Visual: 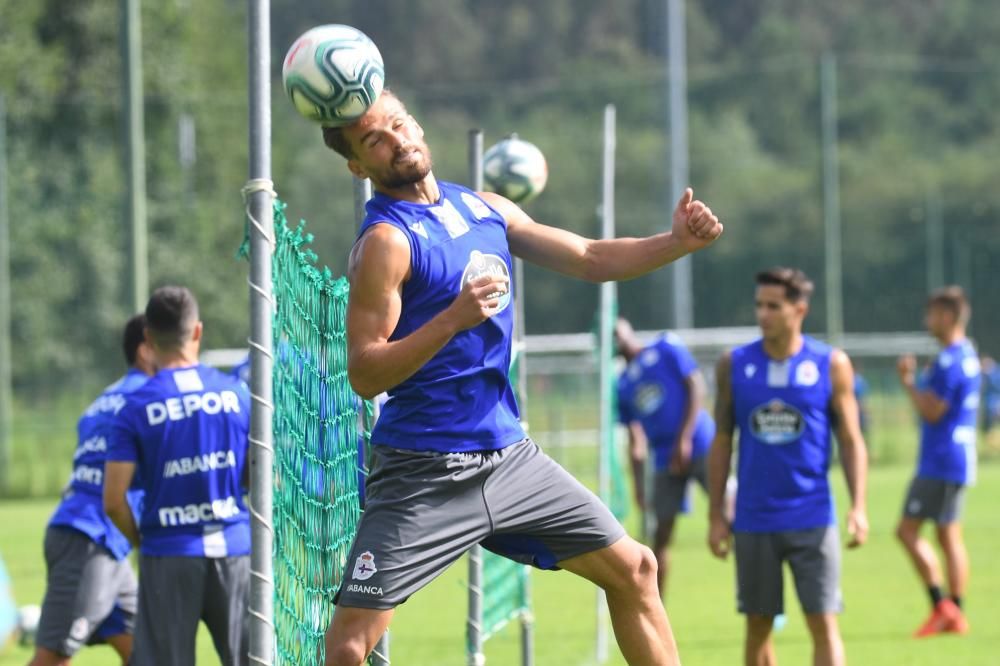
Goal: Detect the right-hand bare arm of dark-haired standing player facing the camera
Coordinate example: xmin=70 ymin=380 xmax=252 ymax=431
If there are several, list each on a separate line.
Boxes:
xmin=830 ymin=349 xmax=868 ymax=548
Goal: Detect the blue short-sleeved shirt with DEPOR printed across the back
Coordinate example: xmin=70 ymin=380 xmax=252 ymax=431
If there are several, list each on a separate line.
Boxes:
xmin=108 ymin=365 xmax=250 ymax=557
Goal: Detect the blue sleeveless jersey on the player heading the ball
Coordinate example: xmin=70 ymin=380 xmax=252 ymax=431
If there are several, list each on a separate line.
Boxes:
xmin=359 ymin=182 xmax=525 ymax=452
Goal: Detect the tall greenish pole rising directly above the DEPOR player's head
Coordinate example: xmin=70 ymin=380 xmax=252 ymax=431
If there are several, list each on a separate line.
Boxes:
xmin=121 ymin=0 xmax=149 ymax=312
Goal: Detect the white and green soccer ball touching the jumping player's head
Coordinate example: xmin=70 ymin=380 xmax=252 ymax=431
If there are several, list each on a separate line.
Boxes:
xmin=281 ymin=24 xmax=385 ymax=127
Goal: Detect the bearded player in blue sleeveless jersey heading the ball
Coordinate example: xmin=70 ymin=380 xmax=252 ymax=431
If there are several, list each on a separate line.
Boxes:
xmin=323 ymin=92 xmax=722 ymax=666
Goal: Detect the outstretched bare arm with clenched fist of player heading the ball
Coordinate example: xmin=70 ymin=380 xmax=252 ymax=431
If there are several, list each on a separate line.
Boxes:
xmin=479 ymin=188 xmax=723 ymax=282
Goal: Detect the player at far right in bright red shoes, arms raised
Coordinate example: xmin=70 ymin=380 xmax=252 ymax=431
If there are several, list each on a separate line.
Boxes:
xmin=896 ymin=287 xmax=980 ymax=637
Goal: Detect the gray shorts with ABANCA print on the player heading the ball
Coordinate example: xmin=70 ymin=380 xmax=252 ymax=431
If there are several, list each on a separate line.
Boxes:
xmin=336 ymin=440 xmax=625 ymax=609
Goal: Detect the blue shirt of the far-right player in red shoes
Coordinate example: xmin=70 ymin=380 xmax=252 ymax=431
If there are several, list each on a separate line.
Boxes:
xmin=917 ymin=340 xmax=980 ymax=485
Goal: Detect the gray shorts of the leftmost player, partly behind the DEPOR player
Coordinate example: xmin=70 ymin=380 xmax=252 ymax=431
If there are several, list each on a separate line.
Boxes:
xmin=35 ymin=526 xmax=137 ymax=657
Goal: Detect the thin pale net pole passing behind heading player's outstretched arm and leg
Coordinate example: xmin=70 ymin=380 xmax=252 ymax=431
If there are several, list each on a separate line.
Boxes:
xmin=596 ymin=104 xmax=617 ymax=664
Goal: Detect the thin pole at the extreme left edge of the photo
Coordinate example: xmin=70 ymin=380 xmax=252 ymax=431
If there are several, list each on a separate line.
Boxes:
xmin=0 ymin=95 xmax=14 ymax=497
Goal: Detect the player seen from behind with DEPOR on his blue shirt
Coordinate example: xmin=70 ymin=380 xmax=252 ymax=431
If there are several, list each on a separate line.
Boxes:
xmin=104 ymin=287 xmax=250 ymax=666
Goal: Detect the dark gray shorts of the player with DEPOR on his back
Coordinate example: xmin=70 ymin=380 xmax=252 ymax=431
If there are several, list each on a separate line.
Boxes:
xmin=129 ymin=555 xmax=250 ymax=666
